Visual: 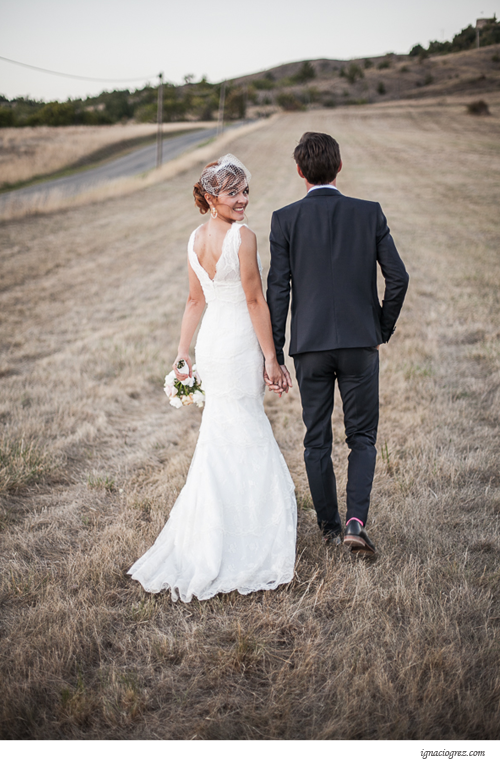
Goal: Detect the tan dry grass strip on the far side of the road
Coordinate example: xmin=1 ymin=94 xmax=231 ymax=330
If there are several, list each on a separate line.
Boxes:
xmin=0 ymin=122 xmax=213 ymax=187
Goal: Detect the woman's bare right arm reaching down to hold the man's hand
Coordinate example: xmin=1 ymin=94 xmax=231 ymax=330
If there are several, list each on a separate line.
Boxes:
xmin=238 ymin=227 xmax=284 ymax=388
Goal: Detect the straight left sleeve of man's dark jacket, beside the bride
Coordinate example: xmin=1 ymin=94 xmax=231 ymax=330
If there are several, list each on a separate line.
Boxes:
xmin=267 ymin=211 xmax=291 ymax=366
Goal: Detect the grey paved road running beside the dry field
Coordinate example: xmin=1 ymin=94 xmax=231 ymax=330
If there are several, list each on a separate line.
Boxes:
xmin=0 ymin=127 xmax=221 ymax=211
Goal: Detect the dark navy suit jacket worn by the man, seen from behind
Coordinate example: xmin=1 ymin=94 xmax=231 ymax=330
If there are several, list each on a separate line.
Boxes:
xmin=267 ymin=187 xmax=409 ymax=364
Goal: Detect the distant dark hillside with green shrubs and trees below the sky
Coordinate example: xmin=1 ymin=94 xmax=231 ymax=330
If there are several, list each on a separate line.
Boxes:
xmin=0 ymin=18 xmax=500 ymax=127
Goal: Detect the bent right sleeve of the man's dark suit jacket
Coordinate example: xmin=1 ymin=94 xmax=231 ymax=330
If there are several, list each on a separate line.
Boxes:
xmin=377 ymin=206 xmax=409 ymax=342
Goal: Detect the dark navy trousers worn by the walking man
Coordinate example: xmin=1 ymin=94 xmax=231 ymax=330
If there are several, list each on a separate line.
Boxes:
xmin=294 ymin=347 xmax=379 ymax=532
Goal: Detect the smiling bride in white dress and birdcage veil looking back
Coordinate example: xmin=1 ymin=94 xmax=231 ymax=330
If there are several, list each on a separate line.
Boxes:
xmin=128 ymin=155 xmax=297 ymax=602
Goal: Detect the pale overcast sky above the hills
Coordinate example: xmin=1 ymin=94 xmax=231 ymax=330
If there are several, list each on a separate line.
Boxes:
xmin=0 ymin=0 xmax=500 ymax=100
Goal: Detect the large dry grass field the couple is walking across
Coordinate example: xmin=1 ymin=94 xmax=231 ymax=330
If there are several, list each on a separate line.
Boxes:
xmin=0 ymin=95 xmax=500 ymax=740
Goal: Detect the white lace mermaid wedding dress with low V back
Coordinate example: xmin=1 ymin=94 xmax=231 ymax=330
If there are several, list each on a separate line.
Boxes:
xmin=128 ymin=223 xmax=297 ymax=602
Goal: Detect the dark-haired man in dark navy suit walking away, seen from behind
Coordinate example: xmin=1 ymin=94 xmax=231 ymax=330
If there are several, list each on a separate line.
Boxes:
xmin=267 ymin=133 xmax=408 ymax=555
